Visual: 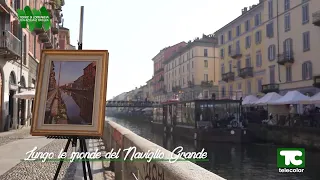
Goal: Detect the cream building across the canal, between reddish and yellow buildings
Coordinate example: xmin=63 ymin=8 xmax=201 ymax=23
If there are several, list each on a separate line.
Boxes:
xmin=164 ymin=35 xmax=219 ymax=99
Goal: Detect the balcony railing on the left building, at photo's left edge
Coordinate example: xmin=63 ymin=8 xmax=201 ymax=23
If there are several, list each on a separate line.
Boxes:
xmin=0 ymin=30 xmax=21 ymax=56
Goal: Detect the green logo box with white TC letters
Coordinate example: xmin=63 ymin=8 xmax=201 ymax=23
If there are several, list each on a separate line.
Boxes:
xmin=277 ymin=148 xmax=306 ymax=168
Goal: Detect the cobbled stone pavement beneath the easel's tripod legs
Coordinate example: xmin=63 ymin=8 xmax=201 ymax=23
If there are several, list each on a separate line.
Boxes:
xmin=0 ymin=128 xmax=114 ymax=180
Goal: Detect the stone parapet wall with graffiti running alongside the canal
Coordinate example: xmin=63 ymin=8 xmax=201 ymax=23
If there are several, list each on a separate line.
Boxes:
xmin=103 ymin=121 xmax=224 ymax=180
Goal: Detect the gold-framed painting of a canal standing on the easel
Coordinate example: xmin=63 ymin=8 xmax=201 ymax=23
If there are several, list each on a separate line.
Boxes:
xmin=30 ymin=50 xmax=109 ymax=137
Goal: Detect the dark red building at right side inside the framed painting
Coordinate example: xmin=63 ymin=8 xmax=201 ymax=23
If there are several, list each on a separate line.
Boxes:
xmin=83 ymin=62 xmax=96 ymax=91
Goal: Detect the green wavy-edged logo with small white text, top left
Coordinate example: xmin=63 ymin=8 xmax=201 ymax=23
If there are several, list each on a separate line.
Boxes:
xmin=17 ymin=6 xmax=51 ymax=31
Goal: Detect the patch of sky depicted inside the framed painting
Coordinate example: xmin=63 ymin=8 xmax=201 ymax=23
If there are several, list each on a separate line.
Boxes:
xmin=53 ymin=61 xmax=92 ymax=86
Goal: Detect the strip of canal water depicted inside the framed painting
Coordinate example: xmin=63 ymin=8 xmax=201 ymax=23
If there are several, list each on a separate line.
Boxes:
xmin=61 ymin=91 xmax=84 ymax=124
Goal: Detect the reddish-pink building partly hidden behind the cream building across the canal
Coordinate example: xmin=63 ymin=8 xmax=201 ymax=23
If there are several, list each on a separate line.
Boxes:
xmin=152 ymin=42 xmax=186 ymax=101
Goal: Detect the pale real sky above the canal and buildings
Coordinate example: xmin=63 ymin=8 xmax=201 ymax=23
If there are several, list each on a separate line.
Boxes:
xmin=62 ymin=0 xmax=259 ymax=99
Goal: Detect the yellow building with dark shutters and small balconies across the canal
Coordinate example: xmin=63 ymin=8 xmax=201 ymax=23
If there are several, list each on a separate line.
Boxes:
xmin=215 ymin=1 xmax=268 ymax=99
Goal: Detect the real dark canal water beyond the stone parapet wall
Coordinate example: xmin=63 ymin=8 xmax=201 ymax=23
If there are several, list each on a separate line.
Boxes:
xmin=107 ymin=117 xmax=320 ymax=180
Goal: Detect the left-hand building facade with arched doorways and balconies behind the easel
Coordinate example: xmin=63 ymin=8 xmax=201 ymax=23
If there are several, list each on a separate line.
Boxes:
xmin=0 ymin=0 xmax=64 ymax=131
